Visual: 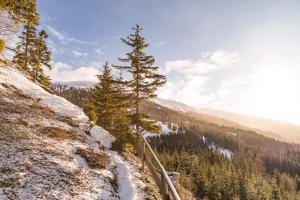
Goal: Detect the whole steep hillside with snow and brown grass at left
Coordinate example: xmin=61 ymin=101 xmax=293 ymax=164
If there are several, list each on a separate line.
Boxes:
xmin=0 ymin=66 xmax=156 ymax=200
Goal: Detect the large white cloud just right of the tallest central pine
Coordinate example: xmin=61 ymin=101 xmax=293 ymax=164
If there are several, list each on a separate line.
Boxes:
xmin=158 ymin=50 xmax=239 ymax=106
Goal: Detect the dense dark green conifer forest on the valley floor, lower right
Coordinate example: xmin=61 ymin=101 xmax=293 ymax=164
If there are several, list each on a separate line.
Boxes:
xmin=150 ymin=130 xmax=300 ymax=200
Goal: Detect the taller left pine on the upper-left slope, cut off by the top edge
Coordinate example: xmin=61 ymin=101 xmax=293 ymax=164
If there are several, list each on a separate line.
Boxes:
xmin=13 ymin=0 xmax=39 ymax=73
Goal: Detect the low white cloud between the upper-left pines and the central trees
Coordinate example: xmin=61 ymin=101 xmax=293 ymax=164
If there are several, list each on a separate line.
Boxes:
xmin=47 ymin=62 xmax=100 ymax=82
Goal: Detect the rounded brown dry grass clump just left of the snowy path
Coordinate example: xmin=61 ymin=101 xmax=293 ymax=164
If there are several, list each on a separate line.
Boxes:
xmin=75 ymin=148 xmax=110 ymax=169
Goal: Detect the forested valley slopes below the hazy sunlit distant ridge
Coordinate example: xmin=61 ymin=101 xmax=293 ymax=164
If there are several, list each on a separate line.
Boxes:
xmin=55 ymin=84 xmax=300 ymax=200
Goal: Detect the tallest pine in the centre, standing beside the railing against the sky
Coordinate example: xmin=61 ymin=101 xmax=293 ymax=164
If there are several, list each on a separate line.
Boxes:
xmin=114 ymin=25 xmax=166 ymax=134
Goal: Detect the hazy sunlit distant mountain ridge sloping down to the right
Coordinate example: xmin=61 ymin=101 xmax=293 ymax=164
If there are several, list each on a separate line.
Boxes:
xmin=154 ymin=98 xmax=300 ymax=144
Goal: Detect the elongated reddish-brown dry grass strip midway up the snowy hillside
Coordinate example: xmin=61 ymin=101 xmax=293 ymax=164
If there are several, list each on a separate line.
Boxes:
xmin=41 ymin=127 xmax=85 ymax=141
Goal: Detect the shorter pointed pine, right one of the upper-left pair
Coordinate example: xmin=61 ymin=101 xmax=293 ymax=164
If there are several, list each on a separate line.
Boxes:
xmin=31 ymin=30 xmax=52 ymax=86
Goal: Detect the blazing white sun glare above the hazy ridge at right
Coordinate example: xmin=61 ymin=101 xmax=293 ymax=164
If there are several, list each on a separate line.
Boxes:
xmin=241 ymin=65 xmax=299 ymax=122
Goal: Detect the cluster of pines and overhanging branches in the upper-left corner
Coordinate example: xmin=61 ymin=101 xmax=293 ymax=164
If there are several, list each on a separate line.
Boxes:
xmin=0 ymin=0 xmax=51 ymax=88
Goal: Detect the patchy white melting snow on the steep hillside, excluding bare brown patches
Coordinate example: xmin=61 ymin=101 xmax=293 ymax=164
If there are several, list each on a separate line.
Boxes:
xmin=0 ymin=66 xmax=145 ymax=200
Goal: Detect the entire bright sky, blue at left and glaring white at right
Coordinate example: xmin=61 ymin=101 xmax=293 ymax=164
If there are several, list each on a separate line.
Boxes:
xmin=38 ymin=0 xmax=300 ymax=124
